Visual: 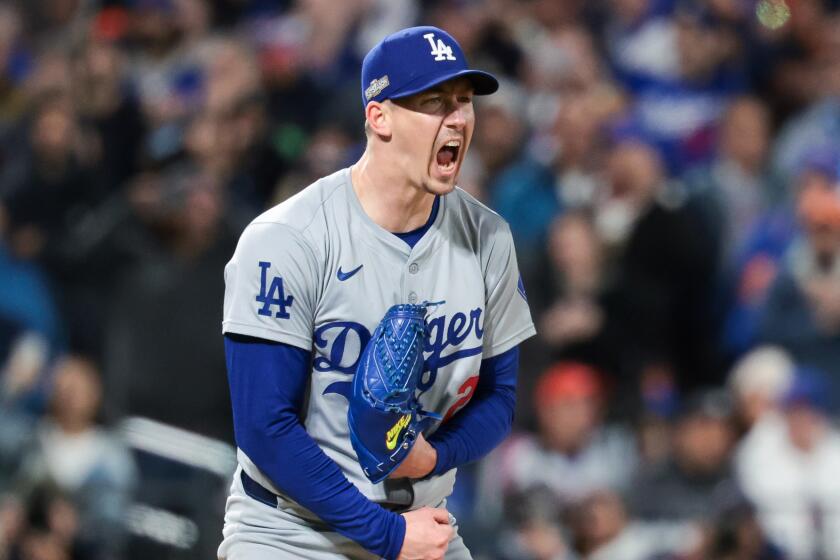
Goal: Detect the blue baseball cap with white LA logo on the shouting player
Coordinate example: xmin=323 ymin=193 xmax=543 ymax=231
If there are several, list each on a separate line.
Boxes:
xmin=362 ymin=25 xmax=499 ymax=107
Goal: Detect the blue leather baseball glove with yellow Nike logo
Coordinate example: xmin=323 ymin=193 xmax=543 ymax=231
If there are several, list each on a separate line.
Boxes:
xmin=347 ymin=303 xmax=440 ymax=483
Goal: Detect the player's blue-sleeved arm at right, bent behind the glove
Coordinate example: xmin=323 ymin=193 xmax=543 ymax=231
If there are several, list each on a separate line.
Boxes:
xmin=429 ymin=348 xmax=519 ymax=475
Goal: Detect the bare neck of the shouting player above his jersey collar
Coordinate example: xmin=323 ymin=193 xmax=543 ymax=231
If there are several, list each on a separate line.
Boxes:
xmin=350 ymin=152 xmax=435 ymax=233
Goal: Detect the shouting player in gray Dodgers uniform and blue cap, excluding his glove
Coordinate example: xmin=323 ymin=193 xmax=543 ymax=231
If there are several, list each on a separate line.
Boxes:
xmin=219 ymin=27 xmax=535 ymax=560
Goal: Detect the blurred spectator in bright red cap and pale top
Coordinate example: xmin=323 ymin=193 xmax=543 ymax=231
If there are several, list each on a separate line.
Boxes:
xmin=485 ymin=362 xmax=636 ymax=516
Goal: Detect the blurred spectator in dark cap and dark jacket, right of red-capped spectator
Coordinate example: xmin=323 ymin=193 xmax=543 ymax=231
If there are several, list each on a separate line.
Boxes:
xmin=629 ymin=390 xmax=734 ymax=522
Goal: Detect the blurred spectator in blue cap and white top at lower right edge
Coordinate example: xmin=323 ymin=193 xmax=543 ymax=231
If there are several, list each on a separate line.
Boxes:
xmin=734 ymin=368 xmax=840 ymax=560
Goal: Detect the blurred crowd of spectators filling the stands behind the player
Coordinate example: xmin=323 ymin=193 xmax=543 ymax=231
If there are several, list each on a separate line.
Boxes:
xmin=0 ymin=0 xmax=840 ymax=560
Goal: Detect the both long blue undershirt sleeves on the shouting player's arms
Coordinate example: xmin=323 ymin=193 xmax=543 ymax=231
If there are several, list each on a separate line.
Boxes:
xmin=225 ymin=334 xmax=519 ymax=559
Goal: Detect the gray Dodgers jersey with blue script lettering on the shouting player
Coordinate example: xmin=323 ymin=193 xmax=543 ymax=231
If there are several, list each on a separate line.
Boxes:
xmin=223 ymin=169 xmax=535 ymax=507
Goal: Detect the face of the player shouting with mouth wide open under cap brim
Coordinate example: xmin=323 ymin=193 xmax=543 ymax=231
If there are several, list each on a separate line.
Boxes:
xmin=391 ymin=78 xmax=475 ymax=194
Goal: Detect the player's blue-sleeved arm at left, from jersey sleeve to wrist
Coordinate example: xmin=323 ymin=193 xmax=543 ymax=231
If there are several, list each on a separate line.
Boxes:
xmin=225 ymin=336 xmax=405 ymax=558
